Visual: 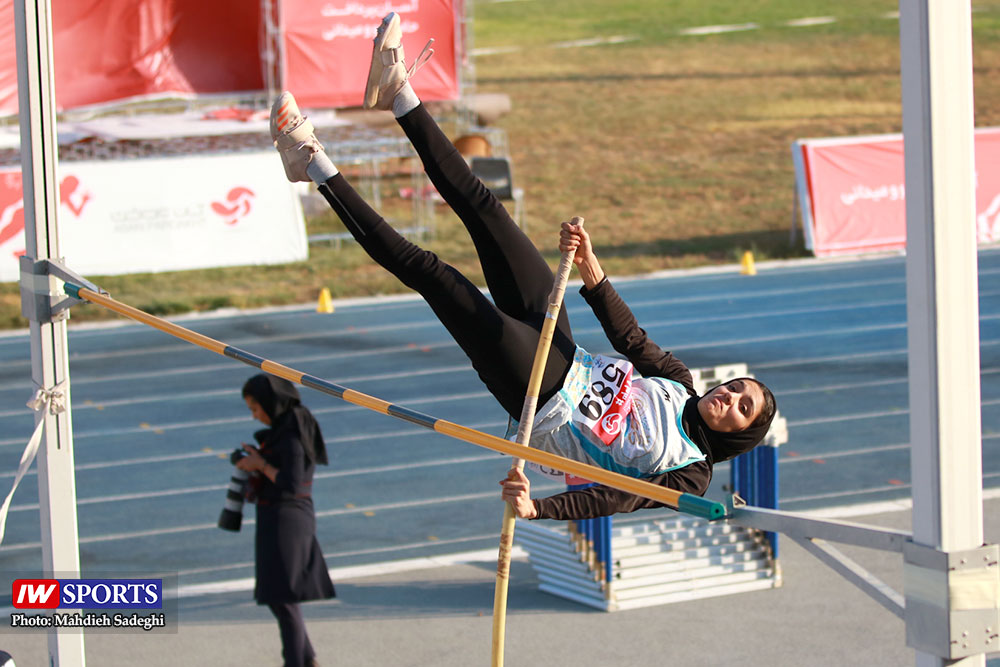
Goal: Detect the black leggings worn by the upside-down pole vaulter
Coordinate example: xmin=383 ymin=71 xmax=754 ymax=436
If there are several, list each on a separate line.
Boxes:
xmin=320 ymin=105 xmax=576 ymax=419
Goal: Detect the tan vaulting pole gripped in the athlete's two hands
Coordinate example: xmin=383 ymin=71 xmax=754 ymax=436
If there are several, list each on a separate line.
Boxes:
xmin=491 ymin=216 xmax=583 ymax=667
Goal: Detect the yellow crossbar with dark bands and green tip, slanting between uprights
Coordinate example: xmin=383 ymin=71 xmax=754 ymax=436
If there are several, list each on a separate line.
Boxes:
xmin=64 ymin=282 xmax=726 ymax=520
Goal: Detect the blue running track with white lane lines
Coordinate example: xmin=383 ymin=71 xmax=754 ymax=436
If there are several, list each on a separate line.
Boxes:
xmin=0 ymin=247 xmax=1000 ymax=584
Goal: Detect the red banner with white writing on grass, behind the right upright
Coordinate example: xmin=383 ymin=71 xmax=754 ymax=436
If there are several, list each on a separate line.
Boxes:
xmin=793 ymin=128 xmax=1000 ymax=257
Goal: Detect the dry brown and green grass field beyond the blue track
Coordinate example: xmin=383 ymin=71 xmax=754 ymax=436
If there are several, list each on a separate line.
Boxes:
xmin=0 ymin=0 xmax=1000 ymax=327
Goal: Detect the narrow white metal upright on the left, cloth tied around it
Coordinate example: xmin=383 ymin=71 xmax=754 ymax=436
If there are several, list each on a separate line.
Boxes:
xmin=14 ymin=0 xmax=86 ymax=667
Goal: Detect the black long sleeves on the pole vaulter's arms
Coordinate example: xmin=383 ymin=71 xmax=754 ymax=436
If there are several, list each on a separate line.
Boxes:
xmin=534 ymin=278 xmax=712 ymax=519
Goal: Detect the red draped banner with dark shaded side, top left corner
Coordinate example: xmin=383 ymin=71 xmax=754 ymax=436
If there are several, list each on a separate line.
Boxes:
xmin=0 ymin=0 xmax=264 ymax=115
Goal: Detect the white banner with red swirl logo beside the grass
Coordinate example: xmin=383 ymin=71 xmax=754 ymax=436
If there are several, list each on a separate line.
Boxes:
xmin=0 ymin=151 xmax=309 ymax=282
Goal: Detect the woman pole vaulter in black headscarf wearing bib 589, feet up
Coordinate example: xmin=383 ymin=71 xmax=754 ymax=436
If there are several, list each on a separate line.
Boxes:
xmin=270 ymin=13 xmax=776 ymax=519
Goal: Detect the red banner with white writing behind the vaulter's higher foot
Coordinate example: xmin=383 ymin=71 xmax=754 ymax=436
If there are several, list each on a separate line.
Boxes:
xmin=284 ymin=0 xmax=460 ymax=107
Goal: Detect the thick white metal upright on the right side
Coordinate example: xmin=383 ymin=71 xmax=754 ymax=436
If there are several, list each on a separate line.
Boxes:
xmin=900 ymin=0 xmax=985 ymax=666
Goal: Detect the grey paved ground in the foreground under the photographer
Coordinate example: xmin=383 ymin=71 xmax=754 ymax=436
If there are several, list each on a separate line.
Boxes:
xmin=0 ymin=500 xmax=1000 ymax=667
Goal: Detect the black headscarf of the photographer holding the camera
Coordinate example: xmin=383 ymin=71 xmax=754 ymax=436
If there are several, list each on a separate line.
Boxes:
xmin=243 ymin=373 xmax=328 ymax=465
